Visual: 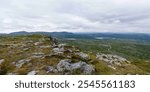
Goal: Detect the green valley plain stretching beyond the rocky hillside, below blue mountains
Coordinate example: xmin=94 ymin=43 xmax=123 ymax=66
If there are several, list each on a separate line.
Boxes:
xmin=60 ymin=39 xmax=150 ymax=72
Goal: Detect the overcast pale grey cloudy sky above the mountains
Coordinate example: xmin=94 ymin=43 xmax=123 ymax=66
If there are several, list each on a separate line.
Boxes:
xmin=0 ymin=0 xmax=150 ymax=33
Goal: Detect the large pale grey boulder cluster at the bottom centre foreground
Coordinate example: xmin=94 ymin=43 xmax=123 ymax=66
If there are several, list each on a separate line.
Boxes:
xmin=47 ymin=59 xmax=95 ymax=75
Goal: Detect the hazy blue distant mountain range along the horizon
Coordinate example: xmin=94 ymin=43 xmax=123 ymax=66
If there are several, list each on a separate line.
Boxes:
xmin=0 ymin=31 xmax=150 ymax=41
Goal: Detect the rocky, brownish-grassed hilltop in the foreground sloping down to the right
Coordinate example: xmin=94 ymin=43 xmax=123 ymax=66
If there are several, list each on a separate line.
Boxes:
xmin=0 ymin=35 xmax=147 ymax=75
